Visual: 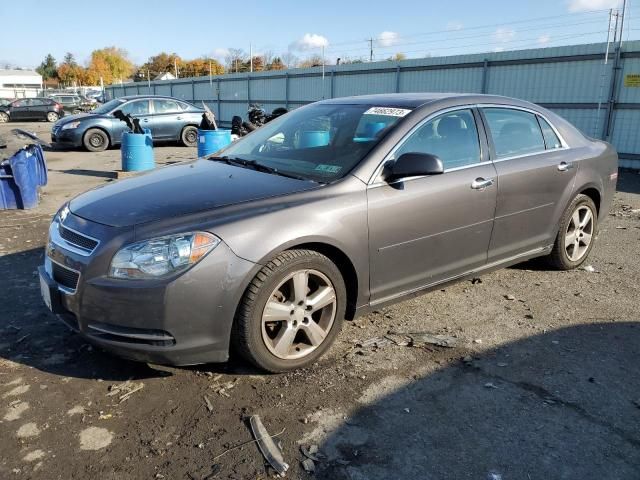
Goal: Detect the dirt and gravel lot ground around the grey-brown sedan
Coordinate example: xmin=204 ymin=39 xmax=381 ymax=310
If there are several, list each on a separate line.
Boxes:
xmin=0 ymin=123 xmax=640 ymax=480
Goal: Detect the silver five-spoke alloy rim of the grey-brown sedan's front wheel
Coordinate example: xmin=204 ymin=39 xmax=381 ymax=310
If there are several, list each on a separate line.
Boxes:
xmin=262 ymin=270 xmax=337 ymax=360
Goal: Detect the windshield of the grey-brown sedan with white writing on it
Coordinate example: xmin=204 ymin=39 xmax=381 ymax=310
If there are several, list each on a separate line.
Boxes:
xmin=218 ymin=104 xmax=410 ymax=183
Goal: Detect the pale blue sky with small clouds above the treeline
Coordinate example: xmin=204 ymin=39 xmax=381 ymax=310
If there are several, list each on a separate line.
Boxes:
xmin=0 ymin=0 xmax=640 ymax=68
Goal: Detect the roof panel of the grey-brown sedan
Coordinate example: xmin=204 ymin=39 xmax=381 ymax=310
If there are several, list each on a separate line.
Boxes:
xmin=319 ymin=92 xmax=532 ymax=108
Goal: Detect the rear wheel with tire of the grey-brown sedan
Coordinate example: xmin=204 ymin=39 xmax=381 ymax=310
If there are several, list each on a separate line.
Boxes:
xmin=549 ymin=194 xmax=598 ymax=270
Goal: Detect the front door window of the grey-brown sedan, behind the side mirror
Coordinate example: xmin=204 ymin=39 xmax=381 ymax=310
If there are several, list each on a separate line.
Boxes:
xmin=393 ymin=109 xmax=480 ymax=170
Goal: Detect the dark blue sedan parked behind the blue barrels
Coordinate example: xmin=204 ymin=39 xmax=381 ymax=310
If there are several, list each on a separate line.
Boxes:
xmin=51 ymin=95 xmax=204 ymax=152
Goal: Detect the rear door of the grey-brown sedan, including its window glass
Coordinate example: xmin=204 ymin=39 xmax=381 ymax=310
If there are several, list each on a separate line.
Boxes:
xmin=482 ymin=107 xmax=576 ymax=262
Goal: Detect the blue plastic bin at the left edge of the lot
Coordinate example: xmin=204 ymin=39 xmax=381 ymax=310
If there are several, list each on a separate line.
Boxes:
xmin=0 ymin=146 xmax=39 ymax=210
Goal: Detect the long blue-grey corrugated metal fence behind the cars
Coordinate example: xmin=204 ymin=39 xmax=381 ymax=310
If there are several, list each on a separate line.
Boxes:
xmin=107 ymin=41 xmax=640 ymax=168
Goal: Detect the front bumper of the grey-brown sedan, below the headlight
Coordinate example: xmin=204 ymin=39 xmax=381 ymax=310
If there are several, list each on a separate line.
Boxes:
xmin=40 ymin=214 xmax=256 ymax=365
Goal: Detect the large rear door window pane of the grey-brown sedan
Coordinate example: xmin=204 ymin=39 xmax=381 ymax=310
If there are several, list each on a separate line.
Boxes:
xmin=483 ymin=108 xmax=545 ymax=158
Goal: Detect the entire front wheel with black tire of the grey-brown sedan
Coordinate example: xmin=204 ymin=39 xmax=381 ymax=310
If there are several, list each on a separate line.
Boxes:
xmin=233 ymin=250 xmax=346 ymax=372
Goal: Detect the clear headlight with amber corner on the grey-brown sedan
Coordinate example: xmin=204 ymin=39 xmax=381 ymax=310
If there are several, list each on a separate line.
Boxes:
xmin=109 ymin=232 xmax=220 ymax=278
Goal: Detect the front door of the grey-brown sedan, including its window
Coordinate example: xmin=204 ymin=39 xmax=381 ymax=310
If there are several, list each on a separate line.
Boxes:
xmin=367 ymin=108 xmax=497 ymax=304
